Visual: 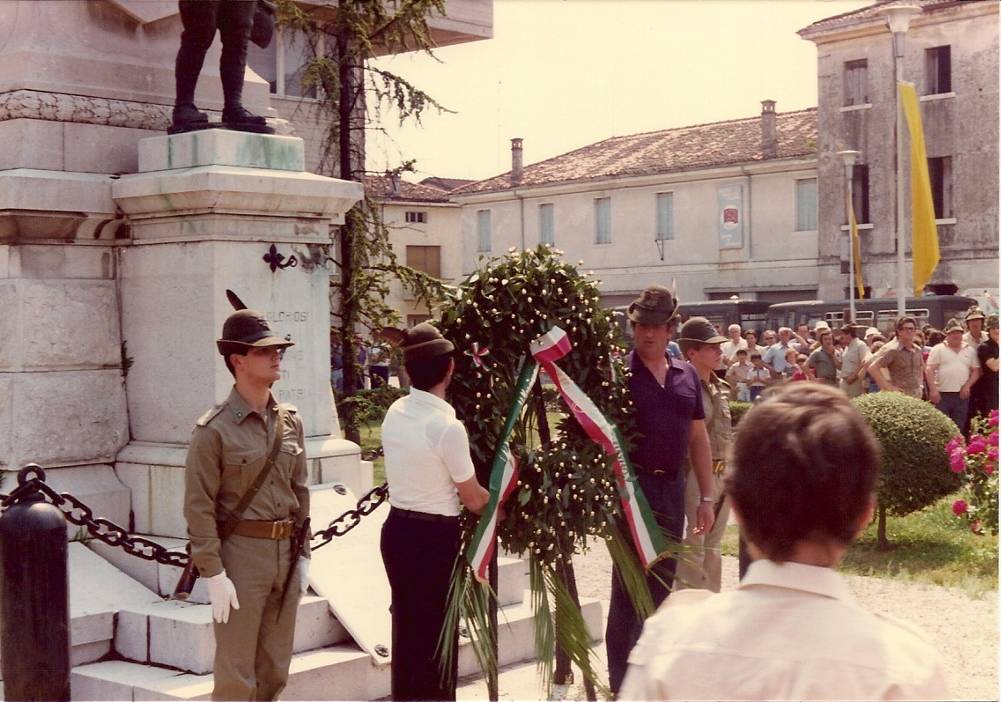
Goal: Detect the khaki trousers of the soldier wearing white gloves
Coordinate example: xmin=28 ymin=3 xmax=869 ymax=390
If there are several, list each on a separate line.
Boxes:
xmin=212 ymin=535 xmax=300 ymax=700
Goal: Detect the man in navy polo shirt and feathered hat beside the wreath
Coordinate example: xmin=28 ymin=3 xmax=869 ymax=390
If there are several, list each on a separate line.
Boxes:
xmin=605 ymin=285 xmax=726 ymax=693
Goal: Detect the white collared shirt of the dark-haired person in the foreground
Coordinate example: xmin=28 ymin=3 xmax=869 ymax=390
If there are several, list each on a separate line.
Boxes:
xmin=619 ymin=560 xmax=948 ymax=700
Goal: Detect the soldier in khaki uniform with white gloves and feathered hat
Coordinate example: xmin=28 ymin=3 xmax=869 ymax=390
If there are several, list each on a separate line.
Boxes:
xmin=184 ymin=309 xmax=309 ymax=700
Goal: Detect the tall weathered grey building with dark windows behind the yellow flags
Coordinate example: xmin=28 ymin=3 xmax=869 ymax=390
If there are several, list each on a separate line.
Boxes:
xmin=799 ymin=0 xmax=999 ymax=295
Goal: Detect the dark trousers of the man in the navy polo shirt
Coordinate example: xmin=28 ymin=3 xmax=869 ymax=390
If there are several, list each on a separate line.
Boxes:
xmin=605 ymin=471 xmax=685 ymax=694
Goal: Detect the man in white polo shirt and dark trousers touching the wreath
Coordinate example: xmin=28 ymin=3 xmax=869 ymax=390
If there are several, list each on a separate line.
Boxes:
xmin=381 ymin=322 xmax=489 ymax=700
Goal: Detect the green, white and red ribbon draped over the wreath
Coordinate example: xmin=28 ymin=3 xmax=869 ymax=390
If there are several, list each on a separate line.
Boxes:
xmin=467 ymin=326 xmax=667 ymax=582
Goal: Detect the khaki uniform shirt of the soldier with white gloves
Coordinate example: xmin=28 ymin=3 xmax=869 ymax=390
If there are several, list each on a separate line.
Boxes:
xmin=184 ymin=388 xmax=309 ymax=578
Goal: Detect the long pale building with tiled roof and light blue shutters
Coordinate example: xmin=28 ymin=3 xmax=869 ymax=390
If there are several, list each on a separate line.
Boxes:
xmin=450 ymin=100 xmax=818 ymax=306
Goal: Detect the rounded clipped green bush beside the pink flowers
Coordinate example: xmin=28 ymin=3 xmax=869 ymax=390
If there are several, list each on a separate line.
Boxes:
xmin=852 ymin=393 xmax=960 ymax=517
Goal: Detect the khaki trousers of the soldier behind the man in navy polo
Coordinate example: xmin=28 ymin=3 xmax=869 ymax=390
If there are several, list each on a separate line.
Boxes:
xmin=675 ymin=470 xmax=730 ymax=592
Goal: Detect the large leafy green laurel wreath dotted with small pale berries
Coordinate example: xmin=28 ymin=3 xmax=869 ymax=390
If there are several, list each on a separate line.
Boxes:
xmin=438 ymin=246 xmax=633 ymax=565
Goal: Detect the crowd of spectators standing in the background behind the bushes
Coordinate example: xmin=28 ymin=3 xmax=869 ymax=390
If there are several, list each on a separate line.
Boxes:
xmin=716 ymin=306 xmax=998 ymax=432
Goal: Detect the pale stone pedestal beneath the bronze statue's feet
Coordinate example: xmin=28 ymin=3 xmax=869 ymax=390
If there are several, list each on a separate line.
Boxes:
xmin=112 ymin=129 xmax=363 ymax=536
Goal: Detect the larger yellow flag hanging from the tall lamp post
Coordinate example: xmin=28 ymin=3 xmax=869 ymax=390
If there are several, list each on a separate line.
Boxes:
xmin=898 ymin=83 xmax=939 ymax=296
